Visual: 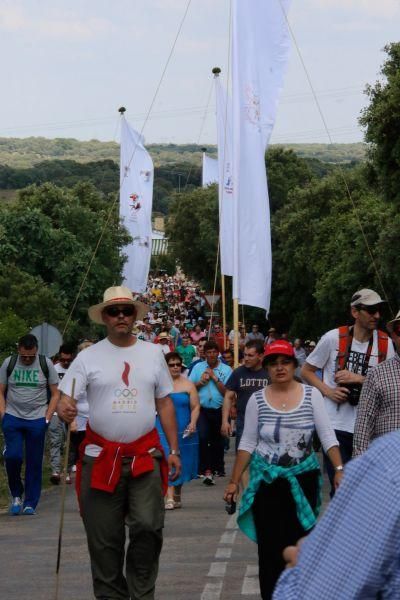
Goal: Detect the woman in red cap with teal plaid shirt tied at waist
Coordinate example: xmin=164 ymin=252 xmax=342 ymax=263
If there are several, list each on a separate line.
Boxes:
xmin=224 ymin=340 xmax=343 ymax=600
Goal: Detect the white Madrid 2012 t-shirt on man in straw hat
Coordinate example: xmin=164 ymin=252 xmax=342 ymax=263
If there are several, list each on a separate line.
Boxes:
xmin=59 ymin=338 xmax=173 ymax=456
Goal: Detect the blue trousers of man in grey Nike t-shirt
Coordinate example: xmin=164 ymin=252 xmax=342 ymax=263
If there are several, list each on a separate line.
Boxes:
xmin=2 ymin=413 xmax=46 ymax=508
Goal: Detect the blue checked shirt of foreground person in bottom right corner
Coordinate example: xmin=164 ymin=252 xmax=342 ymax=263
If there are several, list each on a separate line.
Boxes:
xmin=273 ymin=431 xmax=400 ymax=600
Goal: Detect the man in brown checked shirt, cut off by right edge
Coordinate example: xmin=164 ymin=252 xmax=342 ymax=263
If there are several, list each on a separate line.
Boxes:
xmin=353 ymin=311 xmax=400 ymax=456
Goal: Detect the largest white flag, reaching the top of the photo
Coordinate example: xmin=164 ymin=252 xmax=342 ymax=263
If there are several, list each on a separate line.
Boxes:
xmin=232 ymin=0 xmax=290 ymax=312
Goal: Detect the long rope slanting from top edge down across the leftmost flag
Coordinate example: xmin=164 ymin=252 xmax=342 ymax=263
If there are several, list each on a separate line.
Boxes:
xmin=62 ymin=0 xmax=192 ymax=336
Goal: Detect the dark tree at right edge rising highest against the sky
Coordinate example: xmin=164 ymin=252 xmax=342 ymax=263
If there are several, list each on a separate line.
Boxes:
xmin=360 ymin=42 xmax=400 ymax=207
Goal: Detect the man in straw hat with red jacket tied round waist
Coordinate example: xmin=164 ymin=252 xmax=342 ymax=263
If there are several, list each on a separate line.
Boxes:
xmin=58 ymin=286 xmax=181 ymax=600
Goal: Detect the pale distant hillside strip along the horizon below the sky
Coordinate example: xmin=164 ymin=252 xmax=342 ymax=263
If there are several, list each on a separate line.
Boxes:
xmin=0 ymin=137 xmax=366 ymax=169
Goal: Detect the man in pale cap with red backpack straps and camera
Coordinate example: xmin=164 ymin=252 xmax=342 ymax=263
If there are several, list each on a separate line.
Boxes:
xmin=301 ymin=289 xmax=394 ymax=496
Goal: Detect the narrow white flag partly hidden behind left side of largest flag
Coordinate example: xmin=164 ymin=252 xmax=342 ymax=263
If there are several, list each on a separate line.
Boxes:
xmin=215 ymin=76 xmax=233 ymax=275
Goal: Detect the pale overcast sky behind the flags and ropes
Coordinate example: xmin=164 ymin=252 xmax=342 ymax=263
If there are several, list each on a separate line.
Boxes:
xmin=0 ymin=0 xmax=400 ymax=144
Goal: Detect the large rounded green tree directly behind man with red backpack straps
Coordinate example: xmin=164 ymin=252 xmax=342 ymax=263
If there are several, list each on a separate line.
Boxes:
xmin=271 ymin=169 xmax=398 ymax=336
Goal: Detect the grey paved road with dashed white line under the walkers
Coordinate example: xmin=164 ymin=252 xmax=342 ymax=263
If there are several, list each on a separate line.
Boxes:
xmin=0 ymin=454 xmax=330 ymax=600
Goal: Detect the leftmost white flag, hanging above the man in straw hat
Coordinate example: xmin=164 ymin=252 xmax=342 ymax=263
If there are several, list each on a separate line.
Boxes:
xmin=119 ymin=117 xmax=154 ymax=293
